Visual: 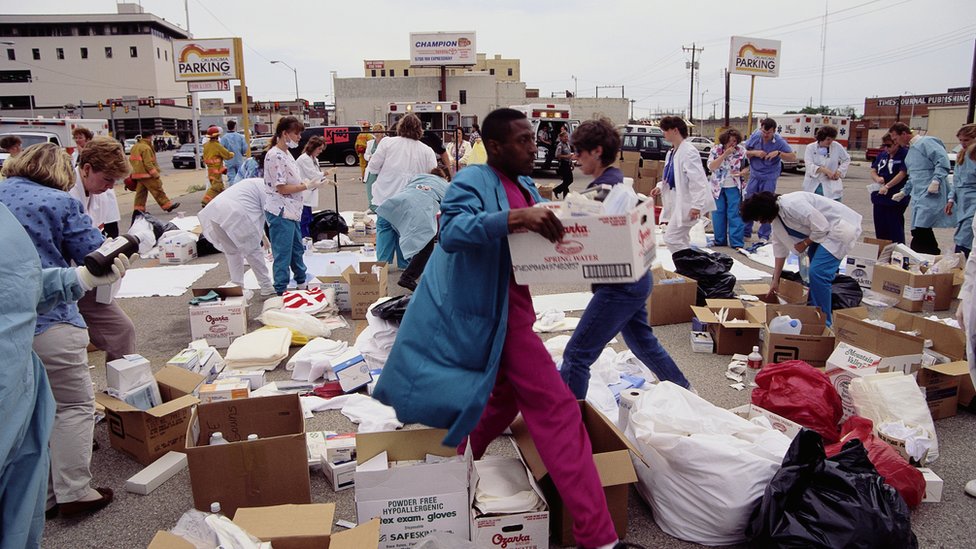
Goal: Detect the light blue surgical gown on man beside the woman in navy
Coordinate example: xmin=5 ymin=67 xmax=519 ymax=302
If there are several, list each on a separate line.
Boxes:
xmin=902 ymin=136 xmax=956 ymax=229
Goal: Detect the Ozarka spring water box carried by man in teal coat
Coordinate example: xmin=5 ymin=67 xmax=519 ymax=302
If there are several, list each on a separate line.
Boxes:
xmin=508 ymin=201 xmax=657 ymax=284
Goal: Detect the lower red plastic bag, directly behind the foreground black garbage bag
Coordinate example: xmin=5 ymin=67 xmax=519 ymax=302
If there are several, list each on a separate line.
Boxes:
xmin=824 ymin=416 xmax=925 ymax=507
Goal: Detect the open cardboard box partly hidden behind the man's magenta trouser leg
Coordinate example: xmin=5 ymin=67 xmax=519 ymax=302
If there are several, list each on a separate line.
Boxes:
xmin=512 ymin=401 xmax=640 ymax=545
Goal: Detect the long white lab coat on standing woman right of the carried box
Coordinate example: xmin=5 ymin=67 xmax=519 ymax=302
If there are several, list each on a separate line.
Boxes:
xmin=657 ymin=140 xmax=715 ymax=253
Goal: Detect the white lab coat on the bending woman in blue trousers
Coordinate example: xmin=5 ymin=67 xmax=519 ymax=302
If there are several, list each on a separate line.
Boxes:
xmin=771 ymin=192 xmax=862 ymax=259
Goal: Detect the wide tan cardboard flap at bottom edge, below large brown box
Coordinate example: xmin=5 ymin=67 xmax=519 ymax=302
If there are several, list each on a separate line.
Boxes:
xmin=234 ymin=503 xmax=335 ymax=542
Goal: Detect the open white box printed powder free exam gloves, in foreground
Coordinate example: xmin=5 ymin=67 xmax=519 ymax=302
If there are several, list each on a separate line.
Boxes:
xmin=355 ymin=429 xmax=474 ymax=549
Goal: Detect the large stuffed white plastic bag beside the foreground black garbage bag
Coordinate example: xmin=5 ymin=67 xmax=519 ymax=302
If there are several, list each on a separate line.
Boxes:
xmin=627 ymin=381 xmax=790 ymax=545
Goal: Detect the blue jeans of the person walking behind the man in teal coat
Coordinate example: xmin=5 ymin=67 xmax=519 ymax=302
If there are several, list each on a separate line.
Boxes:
xmin=560 ymin=274 xmax=691 ymax=398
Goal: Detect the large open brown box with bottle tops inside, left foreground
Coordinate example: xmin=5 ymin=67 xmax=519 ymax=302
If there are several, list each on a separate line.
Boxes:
xmin=185 ymin=394 xmax=312 ymax=516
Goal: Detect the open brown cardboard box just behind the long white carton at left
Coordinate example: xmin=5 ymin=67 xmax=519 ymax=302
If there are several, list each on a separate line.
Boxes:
xmin=95 ymin=366 xmax=204 ymax=464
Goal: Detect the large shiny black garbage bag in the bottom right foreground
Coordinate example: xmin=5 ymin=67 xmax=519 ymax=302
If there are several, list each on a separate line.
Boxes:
xmin=745 ymin=429 xmax=918 ymax=549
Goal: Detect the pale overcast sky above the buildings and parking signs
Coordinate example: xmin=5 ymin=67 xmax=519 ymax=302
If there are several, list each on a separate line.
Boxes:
xmin=7 ymin=0 xmax=976 ymax=118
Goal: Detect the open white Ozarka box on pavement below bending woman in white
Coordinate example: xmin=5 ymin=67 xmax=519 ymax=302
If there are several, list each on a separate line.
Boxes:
xmin=190 ymin=286 xmax=247 ymax=347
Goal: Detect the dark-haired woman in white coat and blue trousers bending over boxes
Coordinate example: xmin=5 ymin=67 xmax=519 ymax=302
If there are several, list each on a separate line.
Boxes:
xmin=742 ymin=192 xmax=862 ymax=326
